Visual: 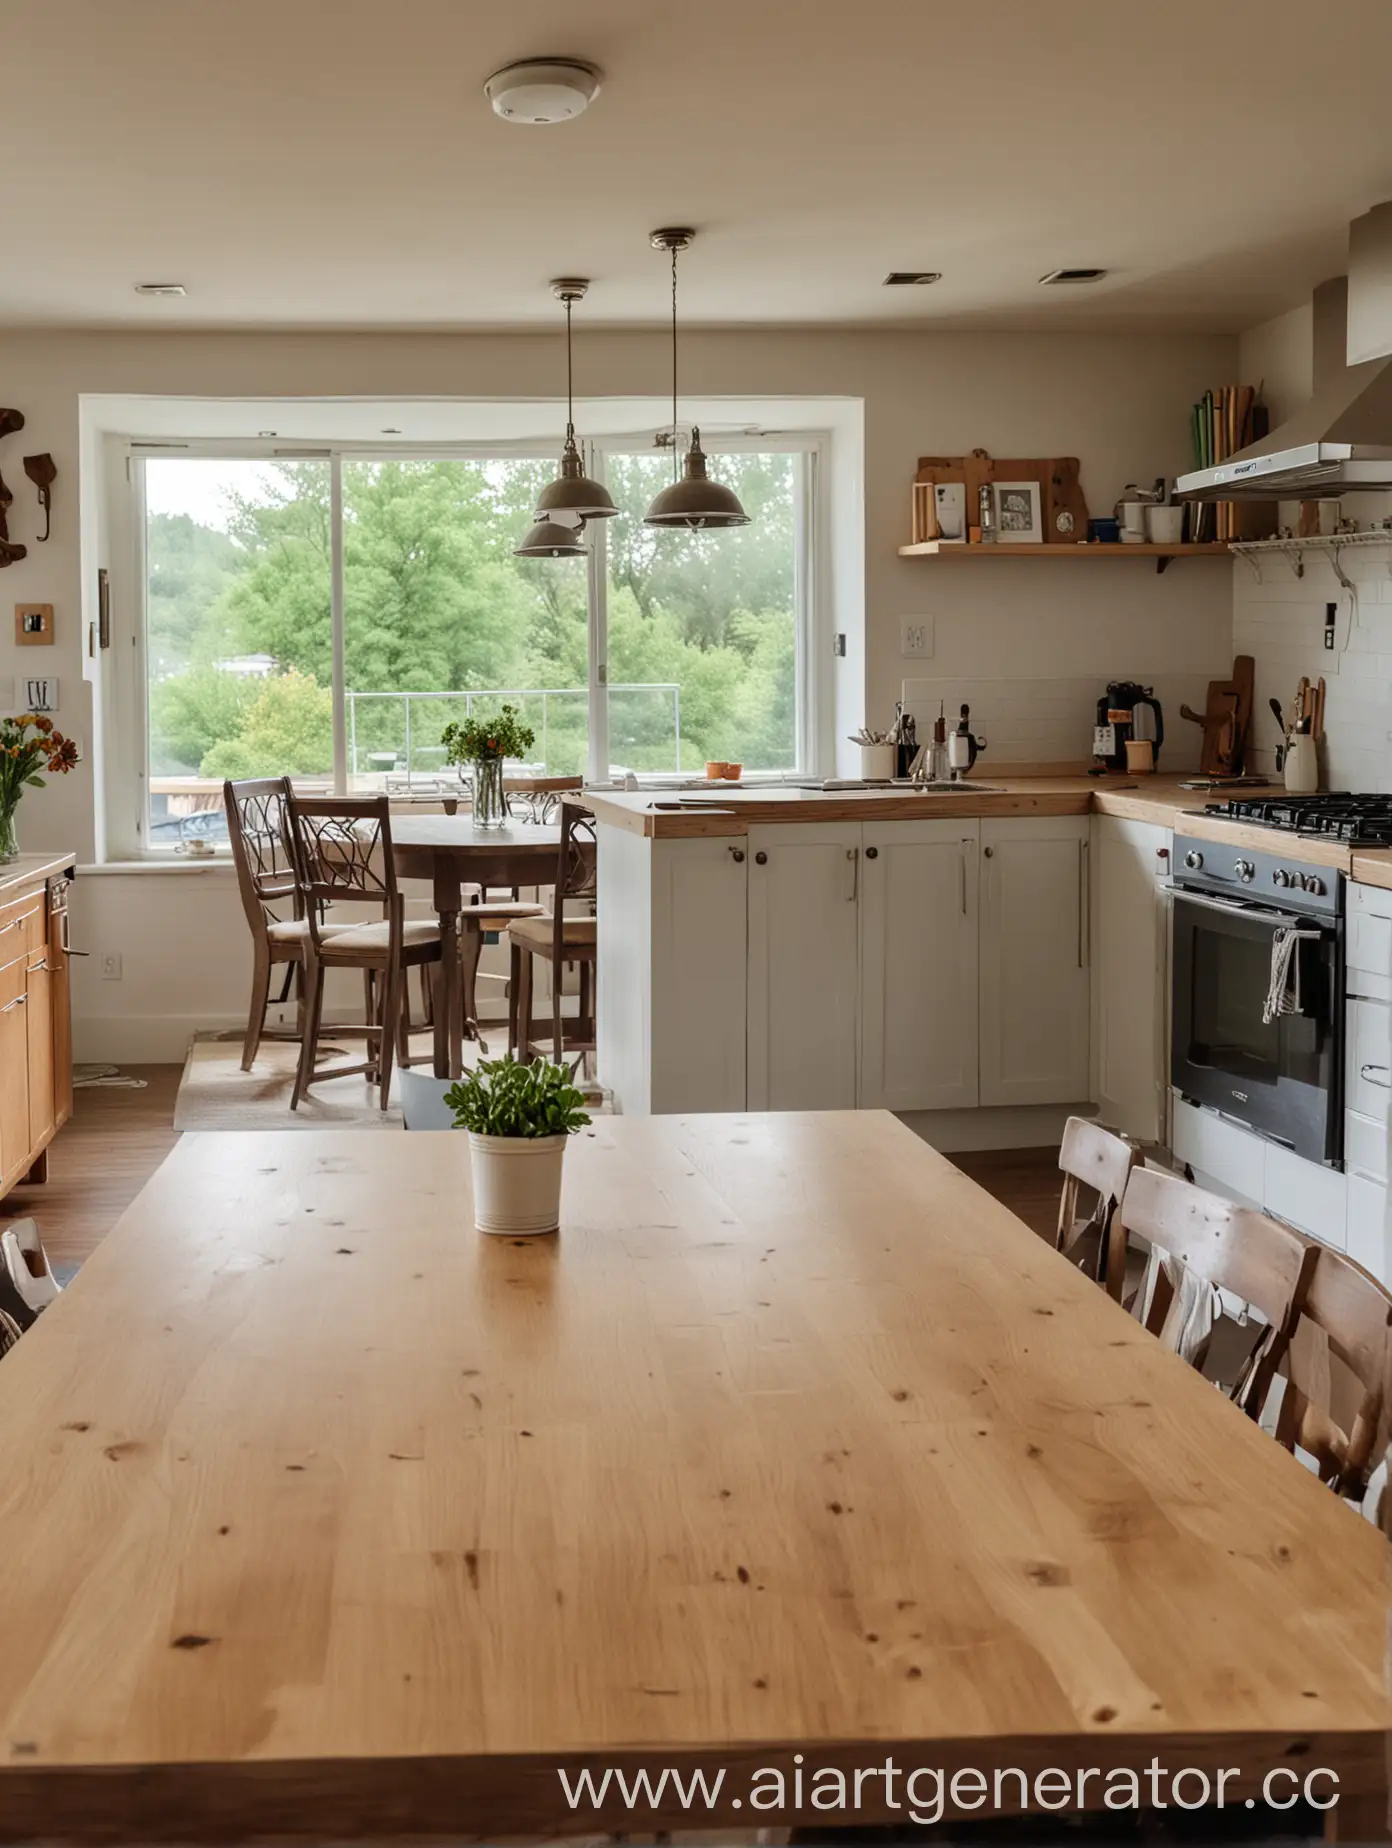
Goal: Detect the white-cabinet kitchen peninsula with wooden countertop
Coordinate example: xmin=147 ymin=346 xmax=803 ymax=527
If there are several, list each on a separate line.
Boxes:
xmin=586 ymin=776 xmax=1212 ymax=1116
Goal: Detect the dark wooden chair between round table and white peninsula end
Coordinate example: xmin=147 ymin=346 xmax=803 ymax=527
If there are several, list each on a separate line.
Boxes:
xmin=508 ymin=802 xmax=599 ymax=1064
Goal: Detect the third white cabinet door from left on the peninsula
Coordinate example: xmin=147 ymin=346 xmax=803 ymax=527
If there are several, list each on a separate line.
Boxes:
xmin=860 ymin=821 xmax=978 ymax=1111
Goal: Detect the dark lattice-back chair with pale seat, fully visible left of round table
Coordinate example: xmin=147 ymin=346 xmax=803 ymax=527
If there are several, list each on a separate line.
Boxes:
xmin=287 ymin=791 xmax=444 ymax=1111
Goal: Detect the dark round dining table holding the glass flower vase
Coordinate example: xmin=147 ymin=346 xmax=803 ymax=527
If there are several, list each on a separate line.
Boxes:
xmin=392 ymin=813 xmax=560 ymax=1077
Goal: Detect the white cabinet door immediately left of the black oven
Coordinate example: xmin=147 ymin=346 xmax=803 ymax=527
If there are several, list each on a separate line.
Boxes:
xmin=1093 ymin=815 xmax=1174 ymax=1142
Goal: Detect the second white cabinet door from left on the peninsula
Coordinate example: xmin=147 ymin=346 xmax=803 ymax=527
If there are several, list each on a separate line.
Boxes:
xmin=747 ymin=822 xmax=860 ymax=1111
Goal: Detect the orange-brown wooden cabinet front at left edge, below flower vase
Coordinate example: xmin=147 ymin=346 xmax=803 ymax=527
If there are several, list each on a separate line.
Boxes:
xmin=0 ymin=881 xmax=72 ymax=1194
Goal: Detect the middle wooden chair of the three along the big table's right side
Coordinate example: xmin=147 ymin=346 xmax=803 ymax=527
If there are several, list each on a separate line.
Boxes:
xmin=1117 ymin=1168 xmax=1316 ymax=1417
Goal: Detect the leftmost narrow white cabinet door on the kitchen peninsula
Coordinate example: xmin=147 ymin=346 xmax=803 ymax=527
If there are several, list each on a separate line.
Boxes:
xmin=651 ymin=839 xmax=749 ymax=1114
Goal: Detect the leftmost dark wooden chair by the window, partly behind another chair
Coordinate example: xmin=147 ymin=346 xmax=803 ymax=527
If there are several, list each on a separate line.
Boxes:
xmin=222 ymin=776 xmax=345 ymax=1072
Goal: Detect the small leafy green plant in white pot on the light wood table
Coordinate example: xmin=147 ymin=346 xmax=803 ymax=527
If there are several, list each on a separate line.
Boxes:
xmin=446 ymin=1053 xmax=590 ymax=1233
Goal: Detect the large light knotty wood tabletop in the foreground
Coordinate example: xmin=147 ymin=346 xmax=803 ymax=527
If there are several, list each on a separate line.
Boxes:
xmin=0 ymin=1112 xmax=1392 ymax=1841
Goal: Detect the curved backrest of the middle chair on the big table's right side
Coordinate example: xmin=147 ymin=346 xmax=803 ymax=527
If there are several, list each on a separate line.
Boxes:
xmin=1118 ymin=1168 xmax=1318 ymax=1414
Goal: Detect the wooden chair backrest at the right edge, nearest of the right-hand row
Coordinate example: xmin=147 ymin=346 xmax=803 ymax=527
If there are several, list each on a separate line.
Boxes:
xmin=1276 ymin=1246 xmax=1392 ymax=1499
